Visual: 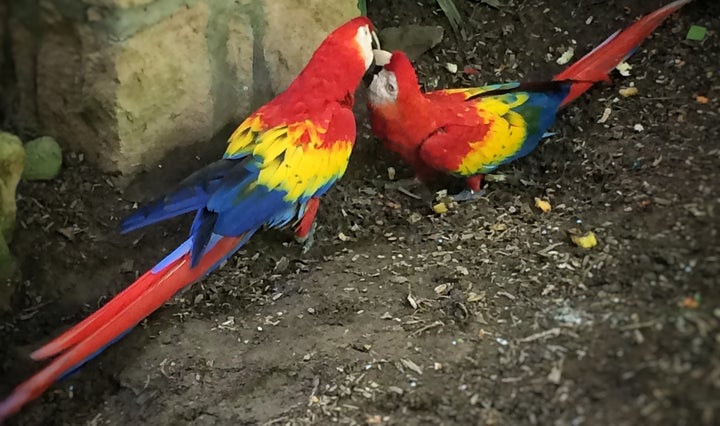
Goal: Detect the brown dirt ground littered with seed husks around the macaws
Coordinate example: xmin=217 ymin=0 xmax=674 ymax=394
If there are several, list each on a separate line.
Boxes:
xmin=0 ymin=0 xmax=720 ymax=425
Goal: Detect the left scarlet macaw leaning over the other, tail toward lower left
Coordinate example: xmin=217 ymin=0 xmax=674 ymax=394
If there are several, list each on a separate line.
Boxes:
xmin=0 ymin=17 xmax=377 ymax=422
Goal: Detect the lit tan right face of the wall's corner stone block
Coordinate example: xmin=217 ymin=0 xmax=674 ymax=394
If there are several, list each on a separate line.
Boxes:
xmin=114 ymin=3 xmax=215 ymax=171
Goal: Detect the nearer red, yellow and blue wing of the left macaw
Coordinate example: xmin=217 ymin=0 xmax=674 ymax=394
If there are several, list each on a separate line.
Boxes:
xmin=191 ymin=104 xmax=355 ymax=262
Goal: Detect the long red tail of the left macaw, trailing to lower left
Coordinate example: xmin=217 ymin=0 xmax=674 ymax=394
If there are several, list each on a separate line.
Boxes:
xmin=0 ymin=236 xmax=245 ymax=423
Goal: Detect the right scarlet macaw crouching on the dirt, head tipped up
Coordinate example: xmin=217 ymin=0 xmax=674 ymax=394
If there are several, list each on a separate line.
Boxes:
xmin=368 ymin=0 xmax=691 ymax=201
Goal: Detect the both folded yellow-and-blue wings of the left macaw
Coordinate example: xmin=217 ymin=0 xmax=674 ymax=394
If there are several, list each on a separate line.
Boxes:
xmin=122 ymin=105 xmax=355 ymax=266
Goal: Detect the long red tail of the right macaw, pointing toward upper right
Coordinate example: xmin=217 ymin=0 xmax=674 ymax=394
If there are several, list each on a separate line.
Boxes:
xmin=554 ymin=0 xmax=692 ymax=106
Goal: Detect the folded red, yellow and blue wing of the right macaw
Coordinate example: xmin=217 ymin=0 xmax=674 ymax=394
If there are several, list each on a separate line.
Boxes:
xmin=420 ymin=82 xmax=570 ymax=177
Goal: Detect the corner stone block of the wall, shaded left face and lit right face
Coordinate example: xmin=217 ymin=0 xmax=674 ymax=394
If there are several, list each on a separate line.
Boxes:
xmin=28 ymin=2 xmax=216 ymax=173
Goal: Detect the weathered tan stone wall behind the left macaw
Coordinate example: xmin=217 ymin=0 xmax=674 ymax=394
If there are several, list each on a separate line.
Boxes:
xmin=0 ymin=0 xmax=359 ymax=175
